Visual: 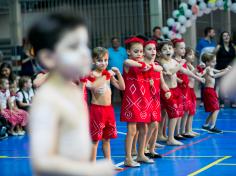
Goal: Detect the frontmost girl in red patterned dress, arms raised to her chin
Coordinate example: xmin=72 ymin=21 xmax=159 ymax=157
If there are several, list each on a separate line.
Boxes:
xmin=121 ymin=37 xmax=158 ymax=167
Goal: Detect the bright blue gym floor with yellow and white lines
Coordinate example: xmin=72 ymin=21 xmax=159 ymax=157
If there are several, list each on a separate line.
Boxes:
xmin=0 ymin=107 xmax=236 ymax=176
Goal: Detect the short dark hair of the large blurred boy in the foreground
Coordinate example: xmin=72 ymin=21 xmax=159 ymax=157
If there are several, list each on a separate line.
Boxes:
xmin=28 ymin=12 xmax=87 ymax=55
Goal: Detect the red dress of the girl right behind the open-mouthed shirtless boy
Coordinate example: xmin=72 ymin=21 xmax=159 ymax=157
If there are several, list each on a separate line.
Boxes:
xmin=177 ymin=63 xmax=190 ymax=116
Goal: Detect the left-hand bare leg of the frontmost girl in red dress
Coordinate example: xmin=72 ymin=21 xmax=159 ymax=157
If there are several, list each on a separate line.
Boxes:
xmin=125 ymin=122 xmax=136 ymax=162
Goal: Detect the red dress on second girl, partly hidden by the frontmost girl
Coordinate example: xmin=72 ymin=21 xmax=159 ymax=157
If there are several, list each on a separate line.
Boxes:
xmin=147 ymin=63 xmax=161 ymax=122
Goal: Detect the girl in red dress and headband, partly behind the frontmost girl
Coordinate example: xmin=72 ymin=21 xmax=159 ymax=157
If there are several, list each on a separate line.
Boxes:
xmin=141 ymin=40 xmax=171 ymax=158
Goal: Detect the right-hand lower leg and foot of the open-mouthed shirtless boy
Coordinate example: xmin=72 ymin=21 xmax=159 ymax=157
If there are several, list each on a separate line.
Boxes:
xmin=167 ymin=118 xmax=183 ymax=145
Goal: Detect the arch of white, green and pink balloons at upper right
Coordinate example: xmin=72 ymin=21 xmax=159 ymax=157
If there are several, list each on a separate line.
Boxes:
xmin=162 ymin=0 xmax=236 ymax=39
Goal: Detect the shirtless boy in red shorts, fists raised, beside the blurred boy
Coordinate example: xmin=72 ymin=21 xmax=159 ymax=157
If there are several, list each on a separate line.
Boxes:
xmin=86 ymin=47 xmax=125 ymax=170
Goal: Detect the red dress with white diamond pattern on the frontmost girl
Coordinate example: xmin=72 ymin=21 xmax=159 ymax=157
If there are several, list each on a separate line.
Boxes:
xmin=120 ymin=67 xmax=151 ymax=123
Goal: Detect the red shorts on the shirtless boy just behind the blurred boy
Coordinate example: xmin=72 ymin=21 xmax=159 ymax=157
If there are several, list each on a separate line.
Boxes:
xmin=89 ymin=104 xmax=117 ymax=141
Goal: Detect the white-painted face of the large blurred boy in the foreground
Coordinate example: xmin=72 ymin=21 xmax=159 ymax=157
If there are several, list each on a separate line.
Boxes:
xmin=55 ymin=26 xmax=91 ymax=79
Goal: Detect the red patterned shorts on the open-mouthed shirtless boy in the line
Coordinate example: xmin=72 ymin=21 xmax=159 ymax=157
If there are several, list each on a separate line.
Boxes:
xmin=163 ymin=87 xmax=184 ymax=119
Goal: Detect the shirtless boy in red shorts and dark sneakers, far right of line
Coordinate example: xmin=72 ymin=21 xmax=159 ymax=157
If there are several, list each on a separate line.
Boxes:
xmin=202 ymin=53 xmax=231 ymax=133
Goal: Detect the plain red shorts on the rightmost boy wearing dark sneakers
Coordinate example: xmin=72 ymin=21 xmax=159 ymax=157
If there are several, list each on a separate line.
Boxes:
xmin=203 ymin=87 xmax=220 ymax=112
